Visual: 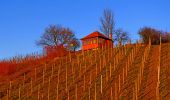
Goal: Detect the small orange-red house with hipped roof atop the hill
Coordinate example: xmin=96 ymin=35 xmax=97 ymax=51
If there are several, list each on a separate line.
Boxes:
xmin=81 ymin=31 xmax=113 ymax=50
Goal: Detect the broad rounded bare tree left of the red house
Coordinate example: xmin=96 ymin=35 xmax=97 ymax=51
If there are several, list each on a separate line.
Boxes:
xmin=37 ymin=25 xmax=80 ymax=51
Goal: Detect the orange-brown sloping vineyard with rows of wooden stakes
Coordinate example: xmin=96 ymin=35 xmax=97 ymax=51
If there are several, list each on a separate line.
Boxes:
xmin=0 ymin=43 xmax=170 ymax=100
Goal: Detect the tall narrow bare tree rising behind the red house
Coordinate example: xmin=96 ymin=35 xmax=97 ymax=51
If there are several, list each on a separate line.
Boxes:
xmin=100 ymin=9 xmax=115 ymax=37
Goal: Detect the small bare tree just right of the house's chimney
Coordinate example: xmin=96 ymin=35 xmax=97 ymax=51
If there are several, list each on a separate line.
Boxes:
xmin=114 ymin=29 xmax=129 ymax=46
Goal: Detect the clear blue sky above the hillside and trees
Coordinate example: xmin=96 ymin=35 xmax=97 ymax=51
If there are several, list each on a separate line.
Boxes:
xmin=0 ymin=0 xmax=170 ymax=59
